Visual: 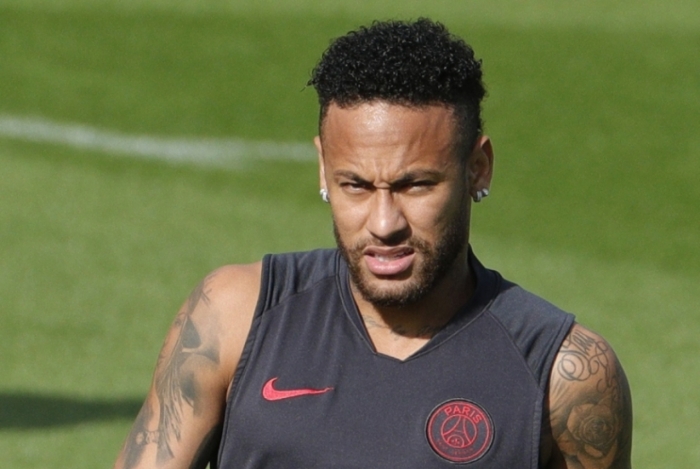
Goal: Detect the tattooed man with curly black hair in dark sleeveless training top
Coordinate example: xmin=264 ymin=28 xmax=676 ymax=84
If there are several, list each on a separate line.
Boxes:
xmin=116 ymin=19 xmax=632 ymax=469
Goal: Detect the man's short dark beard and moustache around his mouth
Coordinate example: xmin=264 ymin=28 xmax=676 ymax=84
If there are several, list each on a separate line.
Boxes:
xmin=333 ymin=201 xmax=468 ymax=308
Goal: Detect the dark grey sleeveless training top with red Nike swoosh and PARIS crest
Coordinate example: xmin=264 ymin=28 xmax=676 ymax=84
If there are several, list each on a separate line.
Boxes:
xmin=218 ymin=250 xmax=573 ymax=469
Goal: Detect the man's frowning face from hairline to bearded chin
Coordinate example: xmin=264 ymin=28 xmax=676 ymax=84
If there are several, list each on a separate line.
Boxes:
xmin=316 ymin=102 xmax=486 ymax=307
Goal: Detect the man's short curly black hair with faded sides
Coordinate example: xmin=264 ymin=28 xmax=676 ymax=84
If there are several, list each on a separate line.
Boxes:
xmin=308 ymin=18 xmax=486 ymax=146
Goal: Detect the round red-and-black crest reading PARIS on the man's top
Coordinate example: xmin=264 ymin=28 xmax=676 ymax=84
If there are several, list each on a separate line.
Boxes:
xmin=426 ymin=399 xmax=494 ymax=464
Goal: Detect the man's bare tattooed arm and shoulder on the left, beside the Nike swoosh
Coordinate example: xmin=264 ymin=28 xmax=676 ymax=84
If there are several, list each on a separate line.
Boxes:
xmin=114 ymin=264 xmax=260 ymax=469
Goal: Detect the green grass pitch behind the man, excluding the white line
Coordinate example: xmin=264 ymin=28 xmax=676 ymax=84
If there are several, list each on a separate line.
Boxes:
xmin=0 ymin=0 xmax=700 ymax=469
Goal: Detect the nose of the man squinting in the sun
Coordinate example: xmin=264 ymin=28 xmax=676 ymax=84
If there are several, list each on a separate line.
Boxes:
xmin=367 ymin=189 xmax=410 ymax=244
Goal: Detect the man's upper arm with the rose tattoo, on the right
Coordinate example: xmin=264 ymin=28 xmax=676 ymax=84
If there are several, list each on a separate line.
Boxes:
xmin=543 ymin=324 xmax=632 ymax=469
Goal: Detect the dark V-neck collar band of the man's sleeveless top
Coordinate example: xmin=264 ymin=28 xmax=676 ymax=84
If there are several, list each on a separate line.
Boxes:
xmin=335 ymin=246 xmax=500 ymax=363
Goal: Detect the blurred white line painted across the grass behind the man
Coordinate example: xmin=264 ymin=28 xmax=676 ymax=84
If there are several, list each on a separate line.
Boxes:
xmin=0 ymin=114 xmax=316 ymax=167
